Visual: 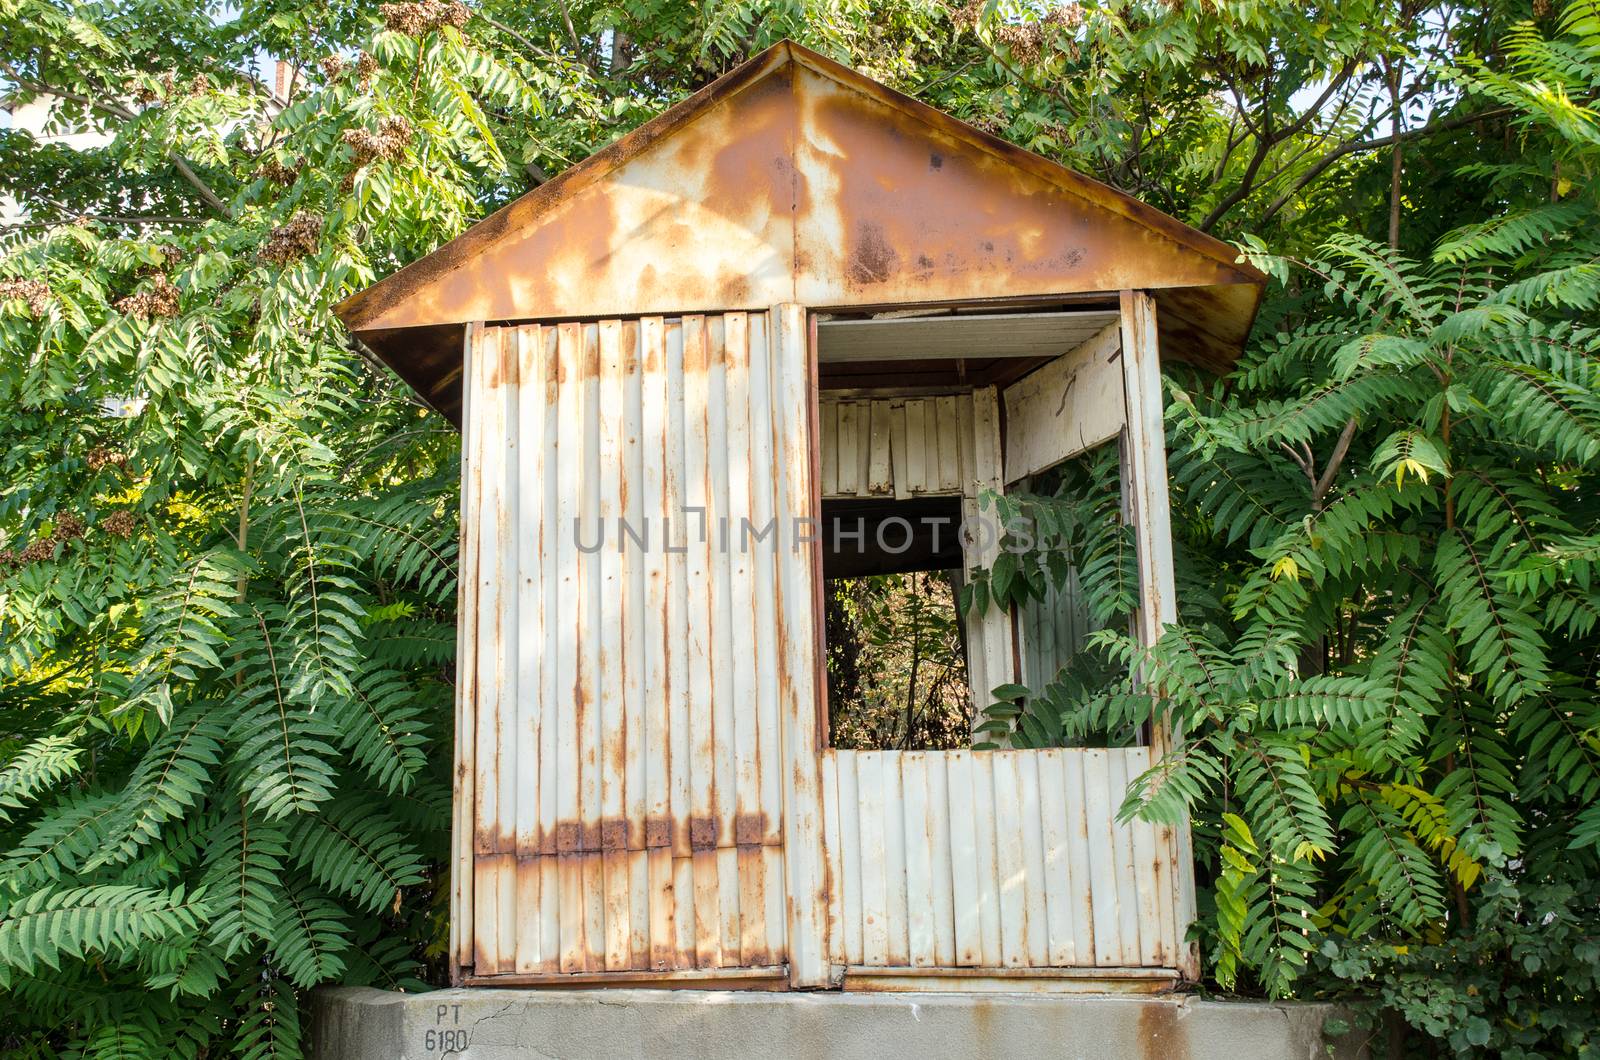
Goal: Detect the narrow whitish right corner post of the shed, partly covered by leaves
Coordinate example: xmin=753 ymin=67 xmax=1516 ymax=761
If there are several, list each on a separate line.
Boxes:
xmin=1118 ymin=290 xmax=1200 ymax=982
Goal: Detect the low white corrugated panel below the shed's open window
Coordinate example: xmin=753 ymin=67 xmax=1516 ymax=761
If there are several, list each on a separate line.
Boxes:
xmin=822 ymin=748 xmax=1178 ymax=969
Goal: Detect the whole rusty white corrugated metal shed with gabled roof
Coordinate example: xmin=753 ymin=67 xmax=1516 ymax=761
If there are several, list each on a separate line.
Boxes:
xmin=338 ymin=42 xmax=1262 ymax=991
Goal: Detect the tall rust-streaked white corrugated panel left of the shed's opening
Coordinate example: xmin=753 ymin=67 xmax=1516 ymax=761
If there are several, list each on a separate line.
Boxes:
xmin=456 ymin=312 xmax=819 ymax=977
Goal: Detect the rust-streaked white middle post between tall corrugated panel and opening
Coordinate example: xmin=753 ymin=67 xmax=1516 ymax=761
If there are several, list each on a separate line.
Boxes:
xmin=768 ymin=303 xmax=834 ymax=990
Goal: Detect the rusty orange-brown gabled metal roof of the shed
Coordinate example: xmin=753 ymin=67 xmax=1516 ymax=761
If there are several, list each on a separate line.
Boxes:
xmin=334 ymin=42 xmax=1264 ymax=420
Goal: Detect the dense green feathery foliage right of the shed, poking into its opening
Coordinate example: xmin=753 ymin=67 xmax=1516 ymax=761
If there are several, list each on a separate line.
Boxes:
xmin=974 ymin=3 xmax=1600 ymax=1057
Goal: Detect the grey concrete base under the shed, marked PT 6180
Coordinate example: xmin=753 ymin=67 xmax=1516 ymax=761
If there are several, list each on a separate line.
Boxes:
xmin=312 ymin=988 xmax=1362 ymax=1060
